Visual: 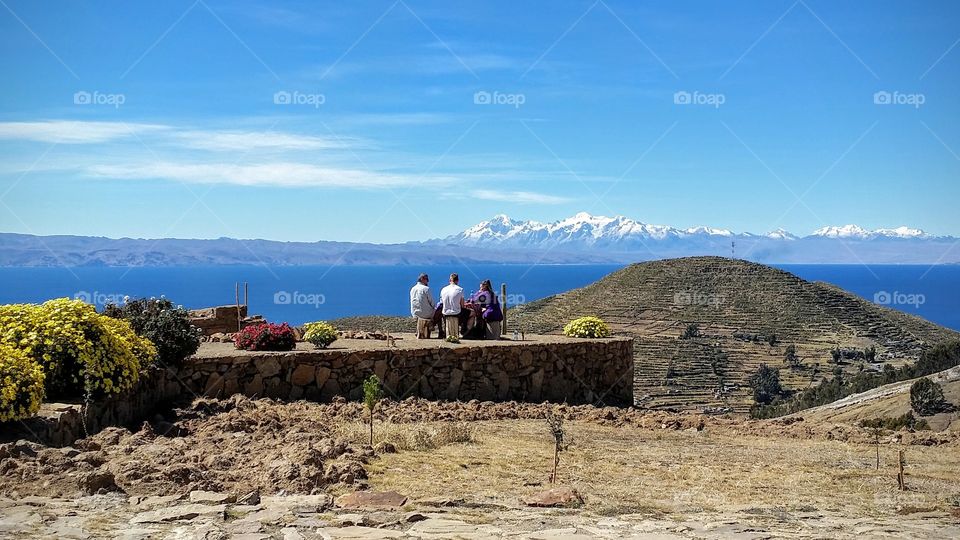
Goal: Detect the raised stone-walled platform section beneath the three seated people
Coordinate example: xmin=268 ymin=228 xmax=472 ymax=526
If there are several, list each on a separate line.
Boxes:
xmin=188 ymin=334 xmax=633 ymax=405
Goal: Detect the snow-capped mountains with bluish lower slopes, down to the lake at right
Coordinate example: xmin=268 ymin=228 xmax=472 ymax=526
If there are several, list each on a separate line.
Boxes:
xmin=432 ymin=212 xmax=960 ymax=264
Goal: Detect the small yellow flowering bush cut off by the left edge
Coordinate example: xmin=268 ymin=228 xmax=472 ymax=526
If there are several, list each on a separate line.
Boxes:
xmin=0 ymin=344 xmax=43 ymax=422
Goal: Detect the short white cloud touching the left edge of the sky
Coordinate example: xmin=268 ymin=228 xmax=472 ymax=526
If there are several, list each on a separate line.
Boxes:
xmin=0 ymin=120 xmax=170 ymax=144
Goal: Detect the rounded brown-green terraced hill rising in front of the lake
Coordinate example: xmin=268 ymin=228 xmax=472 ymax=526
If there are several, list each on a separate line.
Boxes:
xmin=509 ymin=257 xmax=960 ymax=412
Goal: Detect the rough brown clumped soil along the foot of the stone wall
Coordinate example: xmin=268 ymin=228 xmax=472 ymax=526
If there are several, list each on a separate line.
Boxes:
xmin=0 ymin=396 xmax=960 ymax=496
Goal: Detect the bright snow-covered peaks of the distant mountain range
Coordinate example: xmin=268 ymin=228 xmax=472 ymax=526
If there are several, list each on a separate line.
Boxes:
xmin=444 ymin=212 xmax=933 ymax=248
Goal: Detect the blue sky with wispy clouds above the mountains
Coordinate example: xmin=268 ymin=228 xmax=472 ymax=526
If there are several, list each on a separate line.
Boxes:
xmin=0 ymin=0 xmax=960 ymax=242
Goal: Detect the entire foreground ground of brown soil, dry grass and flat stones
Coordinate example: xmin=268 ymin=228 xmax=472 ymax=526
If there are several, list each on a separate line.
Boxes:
xmin=0 ymin=396 xmax=960 ymax=538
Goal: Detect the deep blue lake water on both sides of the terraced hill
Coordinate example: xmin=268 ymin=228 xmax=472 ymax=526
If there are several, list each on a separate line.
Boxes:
xmin=0 ymin=264 xmax=960 ymax=330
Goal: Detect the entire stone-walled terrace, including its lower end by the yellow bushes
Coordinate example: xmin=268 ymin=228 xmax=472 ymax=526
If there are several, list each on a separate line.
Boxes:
xmin=9 ymin=334 xmax=633 ymax=446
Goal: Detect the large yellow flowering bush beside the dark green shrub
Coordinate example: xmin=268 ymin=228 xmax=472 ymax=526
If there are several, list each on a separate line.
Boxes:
xmin=0 ymin=298 xmax=150 ymax=398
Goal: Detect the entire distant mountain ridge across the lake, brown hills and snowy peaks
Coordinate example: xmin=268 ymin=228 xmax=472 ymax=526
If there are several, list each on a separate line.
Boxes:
xmin=0 ymin=212 xmax=960 ymax=267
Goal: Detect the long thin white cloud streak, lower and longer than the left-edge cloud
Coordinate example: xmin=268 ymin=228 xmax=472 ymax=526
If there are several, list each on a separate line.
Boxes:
xmin=85 ymin=161 xmax=453 ymax=189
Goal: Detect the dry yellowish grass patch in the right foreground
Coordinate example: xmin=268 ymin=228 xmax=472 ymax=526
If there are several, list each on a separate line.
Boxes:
xmin=367 ymin=420 xmax=960 ymax=518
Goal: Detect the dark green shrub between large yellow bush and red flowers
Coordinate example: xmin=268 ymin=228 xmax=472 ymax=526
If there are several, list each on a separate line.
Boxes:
xmin=103 ymin=298 xmax=201 ymax=366
